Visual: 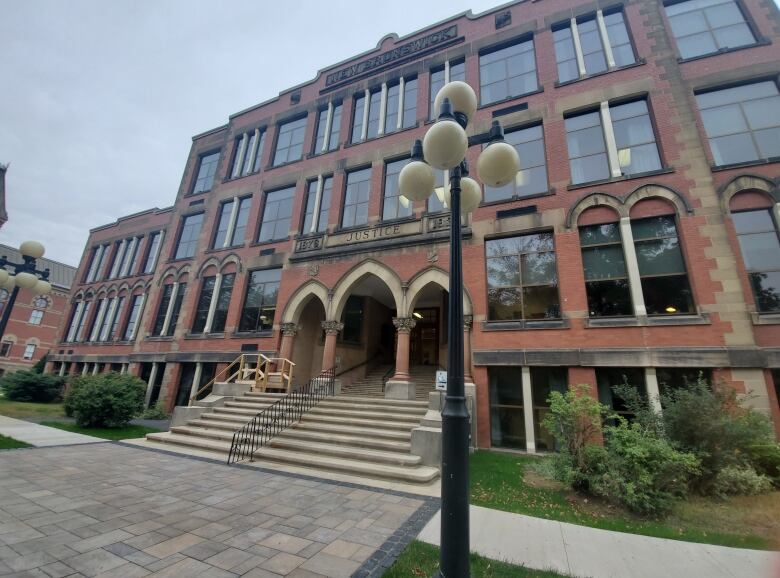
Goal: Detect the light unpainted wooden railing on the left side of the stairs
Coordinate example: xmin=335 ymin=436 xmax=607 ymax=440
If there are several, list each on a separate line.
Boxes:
xmin=190 ymin=353 xmax=295 ymax=405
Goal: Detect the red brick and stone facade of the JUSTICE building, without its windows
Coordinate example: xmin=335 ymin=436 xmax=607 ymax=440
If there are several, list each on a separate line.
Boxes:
xmin=53 ymin=0 xmax=780 ymax=447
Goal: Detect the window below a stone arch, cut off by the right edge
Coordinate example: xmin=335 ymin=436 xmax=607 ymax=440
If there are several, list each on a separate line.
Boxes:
xmin=731 ymin=209 xmax=780 ymax=313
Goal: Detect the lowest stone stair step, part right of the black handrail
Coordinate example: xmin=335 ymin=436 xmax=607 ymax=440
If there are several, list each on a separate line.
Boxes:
xmin=255 ymin=447 xmax=439 ymax=484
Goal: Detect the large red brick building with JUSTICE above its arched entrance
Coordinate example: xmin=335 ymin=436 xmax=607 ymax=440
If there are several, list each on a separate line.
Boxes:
xmin=52 ymin=0 xmax=780 ymax=451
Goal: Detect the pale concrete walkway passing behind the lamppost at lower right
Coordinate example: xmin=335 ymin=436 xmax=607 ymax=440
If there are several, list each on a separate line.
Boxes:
xmin=419 ymin=506 xmax=780 ymax=578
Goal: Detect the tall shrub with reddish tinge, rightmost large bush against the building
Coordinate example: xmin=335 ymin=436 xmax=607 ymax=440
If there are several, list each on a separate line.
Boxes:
xmin=662 ymin=379 xmax=773 ymax=494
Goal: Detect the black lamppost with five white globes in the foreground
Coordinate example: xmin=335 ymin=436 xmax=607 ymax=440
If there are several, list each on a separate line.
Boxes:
xmin=398 ymin=81 xmax=520 ymax=578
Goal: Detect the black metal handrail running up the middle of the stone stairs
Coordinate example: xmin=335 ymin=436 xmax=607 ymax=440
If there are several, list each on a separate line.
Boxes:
xmin=228 ymin=369 xmax=336 ymax=465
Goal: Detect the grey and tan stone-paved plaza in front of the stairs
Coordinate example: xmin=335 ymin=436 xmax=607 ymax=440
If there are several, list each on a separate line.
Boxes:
xmin=0 ymin=443 xmax=438 ymax=578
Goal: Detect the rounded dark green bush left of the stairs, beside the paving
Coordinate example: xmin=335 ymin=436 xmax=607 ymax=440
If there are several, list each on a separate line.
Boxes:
xmin=65 ymin=373 xmax=146 ymax=427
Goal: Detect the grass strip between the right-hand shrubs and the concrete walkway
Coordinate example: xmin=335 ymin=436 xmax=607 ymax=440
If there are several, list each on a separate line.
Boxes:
xmin=471 ymin=451 xmax=780 ymax=550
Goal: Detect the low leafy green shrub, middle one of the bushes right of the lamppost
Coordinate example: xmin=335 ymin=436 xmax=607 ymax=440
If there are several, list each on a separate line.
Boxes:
xmin=584 ymin=419 xmax=699 ymax=517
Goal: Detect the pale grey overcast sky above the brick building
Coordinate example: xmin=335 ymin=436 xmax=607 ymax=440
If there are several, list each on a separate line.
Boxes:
xmin=0 ymin=0 xmax=500 ymax=265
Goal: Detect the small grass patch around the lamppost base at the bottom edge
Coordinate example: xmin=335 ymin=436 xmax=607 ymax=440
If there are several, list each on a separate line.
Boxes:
xmin=382 ymin=541 xmax=564 ymax=578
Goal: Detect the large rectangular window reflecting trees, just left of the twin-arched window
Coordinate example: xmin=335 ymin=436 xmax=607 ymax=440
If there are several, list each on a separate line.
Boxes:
xmin=485 ymin=233 xmax=561 ymax=321
